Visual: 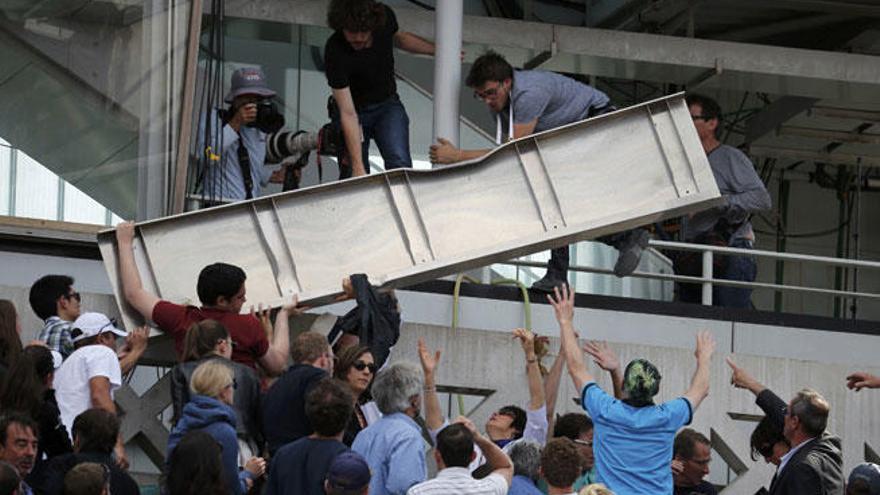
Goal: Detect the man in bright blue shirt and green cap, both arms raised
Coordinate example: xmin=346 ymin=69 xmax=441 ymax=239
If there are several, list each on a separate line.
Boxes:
xmin=547 ymin=286 xmax=715 ymax=495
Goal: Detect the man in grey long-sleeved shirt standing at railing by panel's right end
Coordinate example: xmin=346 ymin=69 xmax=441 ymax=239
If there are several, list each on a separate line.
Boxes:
xmin=676 ymin=94 xmax=772 ymax=308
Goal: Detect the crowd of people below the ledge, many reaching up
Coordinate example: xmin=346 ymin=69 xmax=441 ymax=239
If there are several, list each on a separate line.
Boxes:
xmin=0 ymin=258 xmax=880 ymax=495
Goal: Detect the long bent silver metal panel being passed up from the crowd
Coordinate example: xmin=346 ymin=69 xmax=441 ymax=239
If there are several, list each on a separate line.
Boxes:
xmin=99 ymin=94 xmax=719 ymax=332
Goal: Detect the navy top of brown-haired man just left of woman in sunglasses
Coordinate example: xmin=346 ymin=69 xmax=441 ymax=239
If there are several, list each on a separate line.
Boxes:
xmin=263 ymin=364 xmax=327 ymax=455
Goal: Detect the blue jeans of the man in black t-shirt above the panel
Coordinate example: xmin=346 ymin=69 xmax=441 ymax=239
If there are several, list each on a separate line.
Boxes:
xmin=333 ymin=95 xmax=412 ymax=179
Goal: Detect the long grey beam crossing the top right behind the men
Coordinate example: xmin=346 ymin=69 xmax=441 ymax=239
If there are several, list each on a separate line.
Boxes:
xmin=226 ymin=0 xmax=880 ymax=101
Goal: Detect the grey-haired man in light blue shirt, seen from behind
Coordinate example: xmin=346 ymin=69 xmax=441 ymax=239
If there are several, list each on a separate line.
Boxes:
xmin=351 ymin=363 xmax=428 ymax=495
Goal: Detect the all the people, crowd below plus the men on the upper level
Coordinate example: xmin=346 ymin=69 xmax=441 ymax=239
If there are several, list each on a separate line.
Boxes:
xmin=0 ymin=0 xmax=880 ymax=495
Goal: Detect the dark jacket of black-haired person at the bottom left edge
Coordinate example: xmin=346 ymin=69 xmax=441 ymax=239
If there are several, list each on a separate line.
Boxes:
xmin=28 ymin=452 xmax=140 ymax=495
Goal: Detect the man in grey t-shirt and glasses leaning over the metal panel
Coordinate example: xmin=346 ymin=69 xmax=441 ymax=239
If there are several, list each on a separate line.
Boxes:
xmin=430 ymin=51 xmax=648 ymax=292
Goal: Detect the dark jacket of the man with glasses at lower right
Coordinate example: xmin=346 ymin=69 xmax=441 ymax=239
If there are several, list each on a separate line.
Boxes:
xmin=770 ymin=432 xmax=844 ymax=495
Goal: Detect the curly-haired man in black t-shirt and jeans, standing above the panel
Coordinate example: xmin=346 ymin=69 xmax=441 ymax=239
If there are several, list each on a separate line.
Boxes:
xmin=324 ymin=0 xmax=434 ymax=178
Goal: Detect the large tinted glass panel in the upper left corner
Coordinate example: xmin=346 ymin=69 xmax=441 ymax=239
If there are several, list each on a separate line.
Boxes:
xmin=0 ymin=0 xmax=190 ymax=219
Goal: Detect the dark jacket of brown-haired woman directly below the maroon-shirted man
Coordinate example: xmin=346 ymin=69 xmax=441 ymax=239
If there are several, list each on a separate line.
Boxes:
xmin=171 ymin=355 xmax=263 ymax=447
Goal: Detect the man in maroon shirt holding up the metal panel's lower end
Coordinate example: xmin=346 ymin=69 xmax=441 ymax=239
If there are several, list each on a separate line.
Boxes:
xmin=116 ymin=222 xmax=298 ymax=375
